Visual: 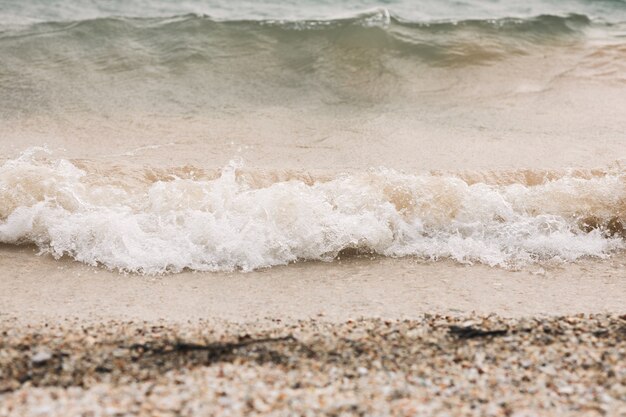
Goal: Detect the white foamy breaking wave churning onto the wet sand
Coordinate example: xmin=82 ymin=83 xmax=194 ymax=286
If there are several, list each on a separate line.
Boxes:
xmin=0 ymin=150 xmax=626 ymax=274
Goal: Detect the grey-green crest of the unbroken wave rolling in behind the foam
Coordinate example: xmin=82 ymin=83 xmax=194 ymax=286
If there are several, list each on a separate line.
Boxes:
xmin=0 ymin=8 xmax=591 ymax=65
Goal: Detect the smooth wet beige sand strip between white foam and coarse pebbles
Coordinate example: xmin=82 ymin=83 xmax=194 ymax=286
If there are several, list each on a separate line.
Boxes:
xmin=0 ymin=245 xmax=626 ymax=323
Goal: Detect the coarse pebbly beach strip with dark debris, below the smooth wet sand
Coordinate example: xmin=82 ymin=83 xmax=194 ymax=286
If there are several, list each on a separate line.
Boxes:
xmin=0 ymin=314 xmax=626 ymax=417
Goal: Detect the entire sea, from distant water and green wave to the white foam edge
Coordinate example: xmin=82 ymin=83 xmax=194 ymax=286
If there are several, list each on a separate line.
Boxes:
xmin=0 ymin=0 xmax=626 ymax=273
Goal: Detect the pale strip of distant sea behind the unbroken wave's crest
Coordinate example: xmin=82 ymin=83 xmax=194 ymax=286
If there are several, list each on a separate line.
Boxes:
xmin=0 ymin=0 xmax=626 ymax=24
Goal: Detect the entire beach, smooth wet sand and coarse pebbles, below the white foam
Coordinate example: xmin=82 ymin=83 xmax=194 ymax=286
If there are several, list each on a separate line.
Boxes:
xmin=0 ymin=246 xmax=626 ymax=417
